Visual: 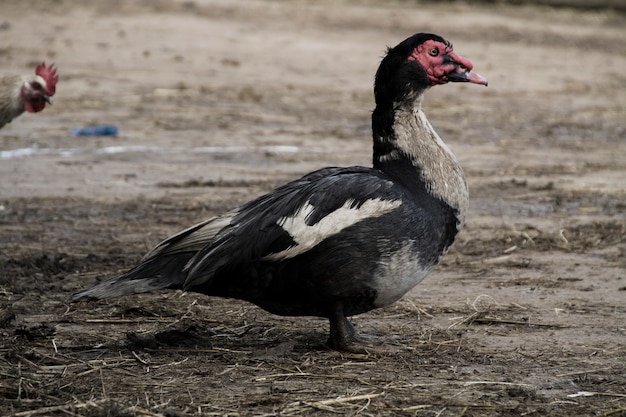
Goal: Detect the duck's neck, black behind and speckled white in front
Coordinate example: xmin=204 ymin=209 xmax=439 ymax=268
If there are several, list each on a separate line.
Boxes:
xmin=372 ymin=92 xmax=469 ymax=228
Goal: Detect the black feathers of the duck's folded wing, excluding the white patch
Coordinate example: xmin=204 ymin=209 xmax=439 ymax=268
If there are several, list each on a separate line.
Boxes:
xmin=184 ymin=167 xmax=397 ymax=289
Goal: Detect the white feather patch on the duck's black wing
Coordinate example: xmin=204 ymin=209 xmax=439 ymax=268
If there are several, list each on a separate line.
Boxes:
xmin=263 ymin=198 xmax=402 ymax=261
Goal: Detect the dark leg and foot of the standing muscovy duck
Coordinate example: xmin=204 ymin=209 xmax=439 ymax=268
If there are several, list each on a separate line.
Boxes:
xmin=328 ymin=302 xmax=379 ymax=353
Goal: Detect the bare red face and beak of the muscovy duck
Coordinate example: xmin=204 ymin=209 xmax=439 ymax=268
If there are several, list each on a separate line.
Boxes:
xmin=408 ymin=39 xmax=487 ymax=86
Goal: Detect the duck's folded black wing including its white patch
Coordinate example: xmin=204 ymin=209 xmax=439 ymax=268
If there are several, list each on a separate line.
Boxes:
xmin=184 ymin=167 xmax=401 ymax=288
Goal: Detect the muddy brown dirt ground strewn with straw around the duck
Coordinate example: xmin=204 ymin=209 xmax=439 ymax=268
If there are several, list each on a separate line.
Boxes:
xmin=0 ymin=0 xmax=626 ymax=416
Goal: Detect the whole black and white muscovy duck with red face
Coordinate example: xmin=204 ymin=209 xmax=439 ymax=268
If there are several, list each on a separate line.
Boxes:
xmin=72 ymin=33 xmax=487 ymax=352
